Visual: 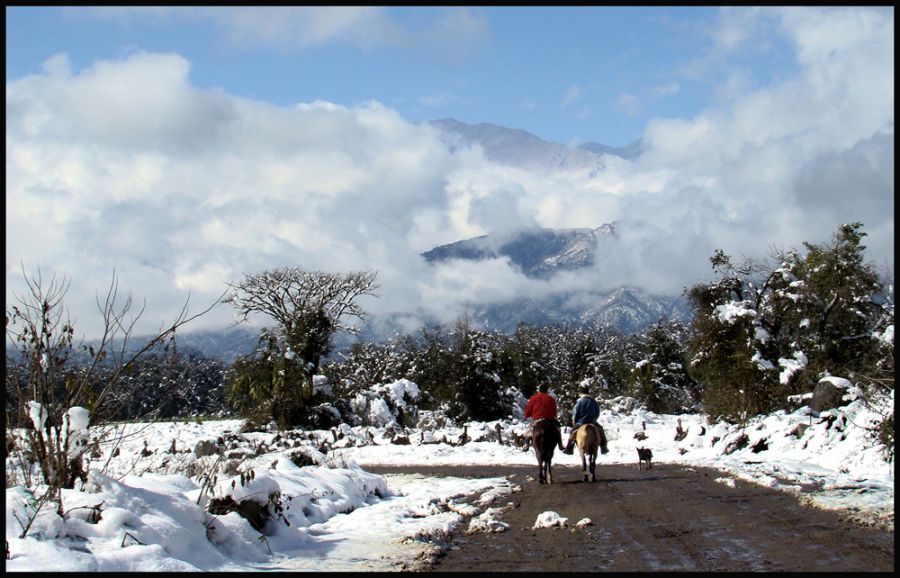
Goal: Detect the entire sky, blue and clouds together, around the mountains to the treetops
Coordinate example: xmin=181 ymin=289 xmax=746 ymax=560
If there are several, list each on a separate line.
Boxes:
xmin=6 ymin=6 xmax=894 ymax=338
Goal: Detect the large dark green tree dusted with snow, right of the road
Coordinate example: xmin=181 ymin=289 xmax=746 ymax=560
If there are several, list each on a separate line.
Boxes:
xmin=687 ymin=223 xmax=884 ymax=420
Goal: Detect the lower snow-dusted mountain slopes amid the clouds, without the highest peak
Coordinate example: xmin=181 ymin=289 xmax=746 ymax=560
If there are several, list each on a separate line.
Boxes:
xmin=178 ymin=224 xmax=690 ymax=362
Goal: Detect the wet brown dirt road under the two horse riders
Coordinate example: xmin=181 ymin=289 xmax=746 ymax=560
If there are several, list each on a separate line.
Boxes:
xmin=367 ymin=464 xmax=894 ymax=572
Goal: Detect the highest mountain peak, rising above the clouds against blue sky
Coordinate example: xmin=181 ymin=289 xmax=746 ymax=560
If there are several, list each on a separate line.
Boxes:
xmin=431 ymin=119 xmax=643 ymax=175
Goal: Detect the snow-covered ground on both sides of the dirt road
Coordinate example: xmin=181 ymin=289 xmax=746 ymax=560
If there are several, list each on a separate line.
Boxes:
xmin=6 ymin=390 xmax=894 ymax=572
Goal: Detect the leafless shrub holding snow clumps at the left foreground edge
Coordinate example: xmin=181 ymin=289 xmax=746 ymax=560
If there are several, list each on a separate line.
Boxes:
xmin=6 ymin=267 xmax=224 ymax=508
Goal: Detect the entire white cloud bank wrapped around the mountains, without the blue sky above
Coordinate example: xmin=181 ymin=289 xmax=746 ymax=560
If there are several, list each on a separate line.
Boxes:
xmin=6 ymin=4 xmax=894 ymax=332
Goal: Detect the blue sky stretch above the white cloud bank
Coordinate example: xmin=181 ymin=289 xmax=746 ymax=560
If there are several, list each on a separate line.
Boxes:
xmin=7 ymin=6 xmax=796 ymax=146
